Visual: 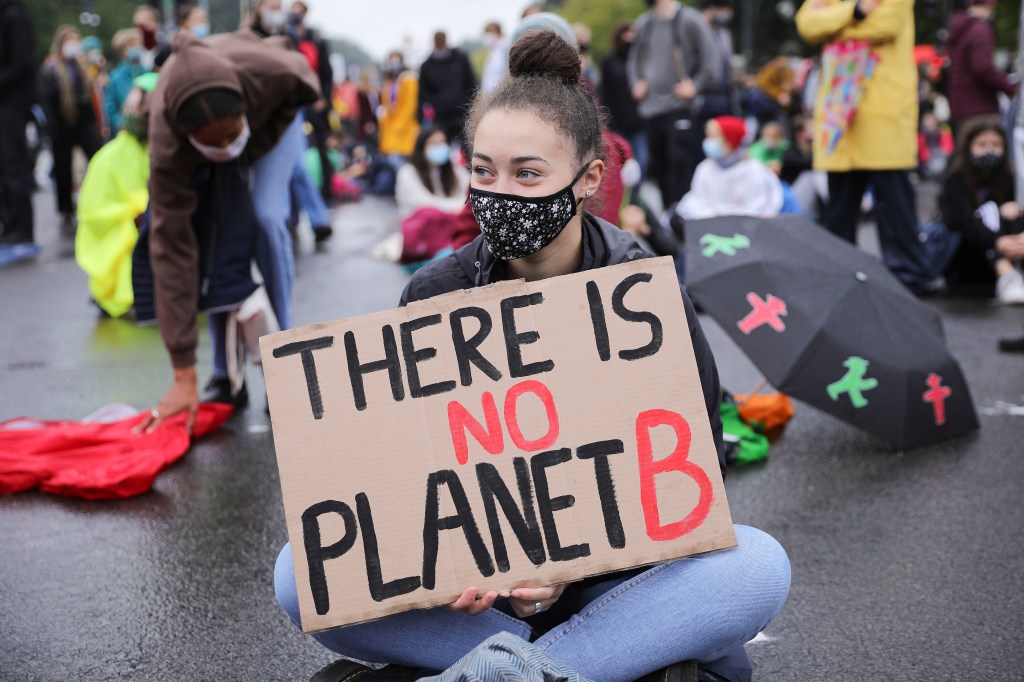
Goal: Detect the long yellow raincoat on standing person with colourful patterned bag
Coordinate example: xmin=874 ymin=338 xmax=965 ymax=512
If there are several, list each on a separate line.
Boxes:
xmin=797 ymin=0 xmax=918 ymax=171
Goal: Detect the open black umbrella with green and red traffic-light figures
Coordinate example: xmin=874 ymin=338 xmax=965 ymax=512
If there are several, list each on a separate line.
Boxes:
xmin=686 ymin=216 xmax=978 ymax=449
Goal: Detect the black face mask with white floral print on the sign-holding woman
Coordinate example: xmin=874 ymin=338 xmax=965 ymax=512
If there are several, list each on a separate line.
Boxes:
xmin=469 ymin=164 xmax=590 ymax=260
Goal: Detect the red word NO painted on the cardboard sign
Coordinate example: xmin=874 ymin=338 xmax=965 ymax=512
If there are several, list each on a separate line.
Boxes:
xmin=449 ymin=380 xmax=558 ymax=464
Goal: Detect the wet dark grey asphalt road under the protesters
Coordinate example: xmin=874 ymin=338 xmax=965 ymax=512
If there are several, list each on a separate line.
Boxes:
xmin=0 ymin=187 xmax=1024 ymax=681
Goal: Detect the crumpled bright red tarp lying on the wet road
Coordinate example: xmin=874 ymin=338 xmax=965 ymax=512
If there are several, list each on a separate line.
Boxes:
xmin=0 ymin=402 xmax=231 ymax=500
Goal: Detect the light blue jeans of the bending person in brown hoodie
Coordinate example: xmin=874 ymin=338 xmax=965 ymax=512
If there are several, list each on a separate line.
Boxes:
xmin=252 ymin=117 xmax=306 ymax=330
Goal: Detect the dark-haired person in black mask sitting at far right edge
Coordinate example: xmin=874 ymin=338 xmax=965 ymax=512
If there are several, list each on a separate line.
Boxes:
xmin=939 ymin=121 xmax=1024 ymax=303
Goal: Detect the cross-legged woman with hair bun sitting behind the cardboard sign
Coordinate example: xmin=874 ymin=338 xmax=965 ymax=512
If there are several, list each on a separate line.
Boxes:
xmin=274 ymin=27 xmax=790 ymax=680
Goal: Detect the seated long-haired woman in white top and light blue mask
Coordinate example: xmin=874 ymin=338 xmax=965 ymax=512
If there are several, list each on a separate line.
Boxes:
xmin=394 ymin=126 xmax=469 ymax=220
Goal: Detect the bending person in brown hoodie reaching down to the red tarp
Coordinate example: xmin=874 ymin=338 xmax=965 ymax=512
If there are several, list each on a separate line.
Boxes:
xmin=140 ymin=31 xmax=319 ymax=428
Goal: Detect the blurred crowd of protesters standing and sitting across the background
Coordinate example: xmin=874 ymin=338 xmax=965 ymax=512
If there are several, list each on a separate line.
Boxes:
xmin=0 ymin=0 xmax=1024 ymax=337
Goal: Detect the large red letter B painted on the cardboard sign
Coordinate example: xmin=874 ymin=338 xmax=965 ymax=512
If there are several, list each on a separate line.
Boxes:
xmin=637 ymin=410 xmax=714 ymax=542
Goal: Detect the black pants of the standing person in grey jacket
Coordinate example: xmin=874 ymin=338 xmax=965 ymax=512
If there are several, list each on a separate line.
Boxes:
xmin=644 ymin=110 xmax=700 ymax=208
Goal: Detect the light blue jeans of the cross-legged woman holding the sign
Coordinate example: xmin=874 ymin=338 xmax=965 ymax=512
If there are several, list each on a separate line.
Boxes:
xmin=274 ymin=525 xmax=790 ymax=682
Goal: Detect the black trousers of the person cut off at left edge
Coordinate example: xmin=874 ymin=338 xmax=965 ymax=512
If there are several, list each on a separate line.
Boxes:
xmin=0 ymin=102 xmax=33 ymax=244
